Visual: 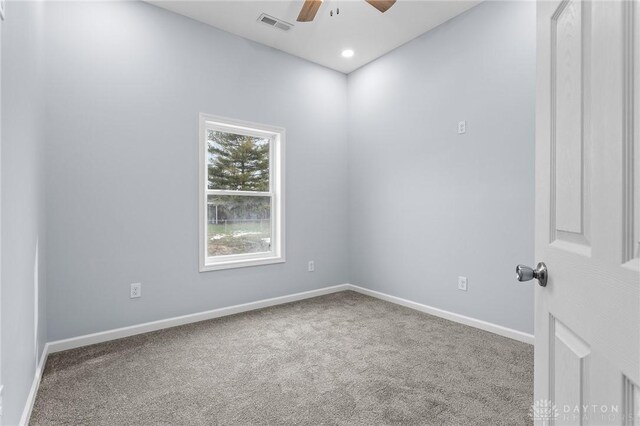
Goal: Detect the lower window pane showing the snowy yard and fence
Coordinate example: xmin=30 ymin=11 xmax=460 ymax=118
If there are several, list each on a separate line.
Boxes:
xmin=207 ymin=195 xmax=271 ymax=256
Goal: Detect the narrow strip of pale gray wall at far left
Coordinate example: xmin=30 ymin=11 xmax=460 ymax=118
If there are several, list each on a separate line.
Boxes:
xmin=1 ymin=2 xmax=47 ymax=425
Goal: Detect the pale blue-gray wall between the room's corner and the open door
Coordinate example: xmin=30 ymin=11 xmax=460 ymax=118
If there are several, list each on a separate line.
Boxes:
xmin=348 ymin=2 xmax=535 ymax=333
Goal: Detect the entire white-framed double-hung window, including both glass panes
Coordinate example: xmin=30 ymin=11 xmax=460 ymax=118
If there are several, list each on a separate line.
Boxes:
xmin=200 ymin=114 xmax=285 ymax=272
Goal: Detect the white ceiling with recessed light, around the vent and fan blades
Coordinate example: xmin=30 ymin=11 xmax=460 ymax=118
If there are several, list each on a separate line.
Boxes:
xmin=148 ymin=0 xmax=480 ymax=73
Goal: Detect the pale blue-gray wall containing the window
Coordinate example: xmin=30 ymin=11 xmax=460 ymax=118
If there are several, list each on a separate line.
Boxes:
xmin=45 ymin=2 xmax=348 ymax=340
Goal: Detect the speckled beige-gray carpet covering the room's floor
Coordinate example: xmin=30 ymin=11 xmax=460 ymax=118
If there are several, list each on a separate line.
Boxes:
xmin=31 ymin=291 xmax=533 ymax=426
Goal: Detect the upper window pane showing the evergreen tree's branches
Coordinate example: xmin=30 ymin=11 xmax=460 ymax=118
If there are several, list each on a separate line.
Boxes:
xmin=207 ymin=130 xmax=269 ymax=191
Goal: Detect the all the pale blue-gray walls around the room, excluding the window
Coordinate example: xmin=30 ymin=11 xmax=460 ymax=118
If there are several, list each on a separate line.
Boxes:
xmin=1 ymin=2 xmax=535 ymax=424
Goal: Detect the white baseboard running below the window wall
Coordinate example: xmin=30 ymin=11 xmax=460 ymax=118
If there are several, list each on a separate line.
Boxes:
xmin=48 ymin=284 xmax=349 ymax=353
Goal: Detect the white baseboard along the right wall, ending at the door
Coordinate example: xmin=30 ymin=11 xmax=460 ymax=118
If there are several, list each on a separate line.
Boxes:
xmin=347 ymin=284 xmax=535 ymax=345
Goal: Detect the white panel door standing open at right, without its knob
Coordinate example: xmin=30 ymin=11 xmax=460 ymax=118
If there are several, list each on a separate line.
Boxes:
xmin=532 ymin=0 xmax=640 ymax=425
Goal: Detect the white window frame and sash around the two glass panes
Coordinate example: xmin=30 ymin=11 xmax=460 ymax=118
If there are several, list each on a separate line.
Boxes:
xmin=198 ymin=113 xmax=285 ymax=272
